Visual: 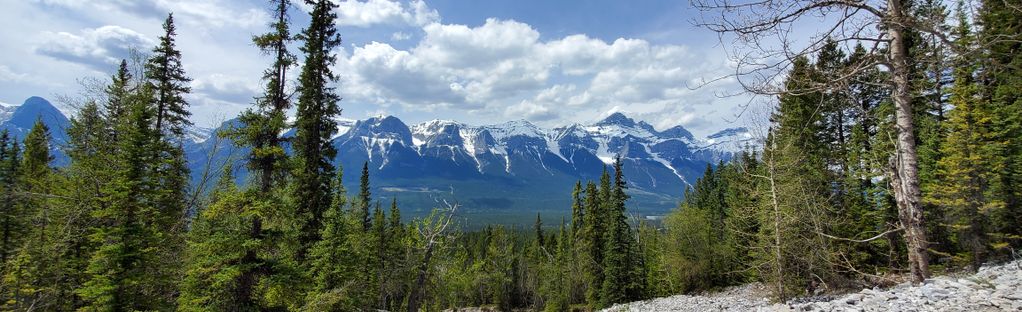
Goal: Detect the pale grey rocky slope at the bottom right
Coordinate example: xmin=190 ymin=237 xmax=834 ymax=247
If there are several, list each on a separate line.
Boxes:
xmin=604 ymin=261 xmax=1022 ymax=312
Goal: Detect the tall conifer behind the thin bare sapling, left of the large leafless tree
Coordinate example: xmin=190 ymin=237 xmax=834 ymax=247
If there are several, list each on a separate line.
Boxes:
xmin=760 ymin=57 xmax=834 ymax=299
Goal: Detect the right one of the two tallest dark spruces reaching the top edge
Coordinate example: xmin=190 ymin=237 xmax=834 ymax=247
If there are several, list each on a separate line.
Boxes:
xmin=292 ymin=0 xmax=340 ymax=253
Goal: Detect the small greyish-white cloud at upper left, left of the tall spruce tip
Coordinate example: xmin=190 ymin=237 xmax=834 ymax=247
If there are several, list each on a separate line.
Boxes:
xmin=35 ymin=26 xmax=154 ymax=72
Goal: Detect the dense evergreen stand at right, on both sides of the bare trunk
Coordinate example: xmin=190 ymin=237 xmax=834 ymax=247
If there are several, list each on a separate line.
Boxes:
xmin=665 ymin=1 xmax=1022 ymax=299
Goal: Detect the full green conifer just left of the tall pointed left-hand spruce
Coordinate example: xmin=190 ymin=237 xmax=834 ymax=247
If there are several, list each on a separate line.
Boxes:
xmin=77 ymin=81 xmax=166 ymax=311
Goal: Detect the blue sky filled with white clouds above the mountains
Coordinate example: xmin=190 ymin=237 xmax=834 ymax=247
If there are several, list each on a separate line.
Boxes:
xmin=0 ymin=0 xmax=749 ymax=135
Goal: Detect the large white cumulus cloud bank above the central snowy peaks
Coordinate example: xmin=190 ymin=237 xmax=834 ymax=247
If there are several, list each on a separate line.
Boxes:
xmin=337 ymin=18 xmax=744 ymax=131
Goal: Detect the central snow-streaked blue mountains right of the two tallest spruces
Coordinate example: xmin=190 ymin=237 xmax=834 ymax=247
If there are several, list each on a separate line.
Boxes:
xmin=318 ymin=109 xmax=752 ymax=212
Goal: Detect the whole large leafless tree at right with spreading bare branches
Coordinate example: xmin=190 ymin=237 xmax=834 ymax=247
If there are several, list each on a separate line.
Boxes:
xmin=692 ymin=0 xmax=951 ymax=282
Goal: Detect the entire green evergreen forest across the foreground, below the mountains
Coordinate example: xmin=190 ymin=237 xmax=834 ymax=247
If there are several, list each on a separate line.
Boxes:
xmin=0 ymin=0 xmax=1022 ymax=311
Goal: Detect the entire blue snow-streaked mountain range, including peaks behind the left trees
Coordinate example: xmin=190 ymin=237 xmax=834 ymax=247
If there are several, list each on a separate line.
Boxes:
xmin=0 ymin=97 xmax=757 ymax=223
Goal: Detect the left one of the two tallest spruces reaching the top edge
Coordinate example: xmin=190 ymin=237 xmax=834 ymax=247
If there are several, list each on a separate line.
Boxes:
xmin=204 ymin=0 xmax=296 ymax=307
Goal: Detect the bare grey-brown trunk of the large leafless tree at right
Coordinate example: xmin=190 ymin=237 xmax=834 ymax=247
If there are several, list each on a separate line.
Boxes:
xmin=886 ymin=0 xmax=930 ymax=283
